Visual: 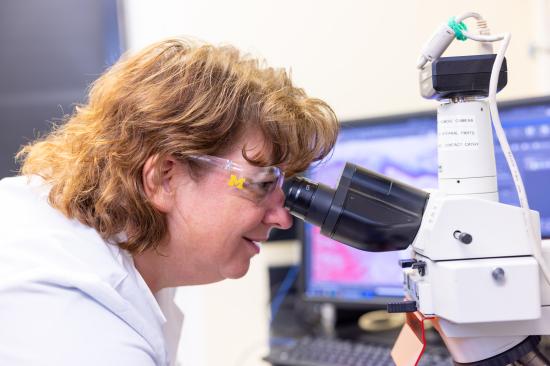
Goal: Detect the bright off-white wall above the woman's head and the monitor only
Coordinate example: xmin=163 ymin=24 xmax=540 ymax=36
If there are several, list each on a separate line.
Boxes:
xmin=127 ymin=0 xmax=545 ymax=119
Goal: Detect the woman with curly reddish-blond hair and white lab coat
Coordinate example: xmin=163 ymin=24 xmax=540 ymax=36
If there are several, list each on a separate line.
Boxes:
xmin=0 ymin=39 xmax=337 ymax=366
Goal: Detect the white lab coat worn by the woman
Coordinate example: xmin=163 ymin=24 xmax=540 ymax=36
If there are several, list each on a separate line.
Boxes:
xmin=0 ymin=177 xmax=182 ymax=366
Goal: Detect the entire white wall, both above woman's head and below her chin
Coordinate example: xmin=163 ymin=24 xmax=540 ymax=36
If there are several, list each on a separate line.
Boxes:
xmin=125 ymin=0 xmax=549 ymax=366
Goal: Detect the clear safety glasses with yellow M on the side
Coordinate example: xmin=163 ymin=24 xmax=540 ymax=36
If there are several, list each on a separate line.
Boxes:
xmin=188 ymin=155 xmax=284 ymax=203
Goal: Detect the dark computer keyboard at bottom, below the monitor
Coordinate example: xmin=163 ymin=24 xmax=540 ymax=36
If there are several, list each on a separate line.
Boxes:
xmin=264 ymin=337 xmax=453 ymax=366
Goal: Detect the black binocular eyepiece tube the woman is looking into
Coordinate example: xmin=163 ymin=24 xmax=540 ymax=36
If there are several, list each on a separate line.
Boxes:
xmin=285 ymin=163 xmax=429 ymax=252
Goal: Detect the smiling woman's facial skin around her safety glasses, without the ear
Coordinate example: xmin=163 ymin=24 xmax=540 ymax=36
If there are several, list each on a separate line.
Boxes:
xmin=161 ymin=133 xmax=292 ymax=284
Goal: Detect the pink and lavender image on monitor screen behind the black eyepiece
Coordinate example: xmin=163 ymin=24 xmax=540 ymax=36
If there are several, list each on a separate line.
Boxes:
xmin=308 ymin=130 xmax=437 ymax=288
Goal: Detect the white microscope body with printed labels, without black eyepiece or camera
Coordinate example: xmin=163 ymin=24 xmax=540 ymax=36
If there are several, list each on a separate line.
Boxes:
xmin=404 ymin=100 xmax=550 ymax=363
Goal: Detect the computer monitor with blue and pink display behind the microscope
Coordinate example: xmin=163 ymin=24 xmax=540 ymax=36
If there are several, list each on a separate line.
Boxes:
xmin=302 ymin=97 xmax=550 ymax=307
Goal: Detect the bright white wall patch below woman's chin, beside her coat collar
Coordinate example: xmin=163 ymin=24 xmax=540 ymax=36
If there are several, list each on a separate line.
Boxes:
xmin=176 ymin=255 xmax=269 ymax=366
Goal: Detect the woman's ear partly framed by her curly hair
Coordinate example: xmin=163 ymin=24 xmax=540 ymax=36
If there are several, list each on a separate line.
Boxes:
xmin=142 ymin=155 xmax=182 ymax=213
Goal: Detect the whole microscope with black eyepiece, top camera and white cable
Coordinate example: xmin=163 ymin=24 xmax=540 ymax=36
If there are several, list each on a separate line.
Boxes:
xmin=285 ymin=13 xmax=550 ymax=366
